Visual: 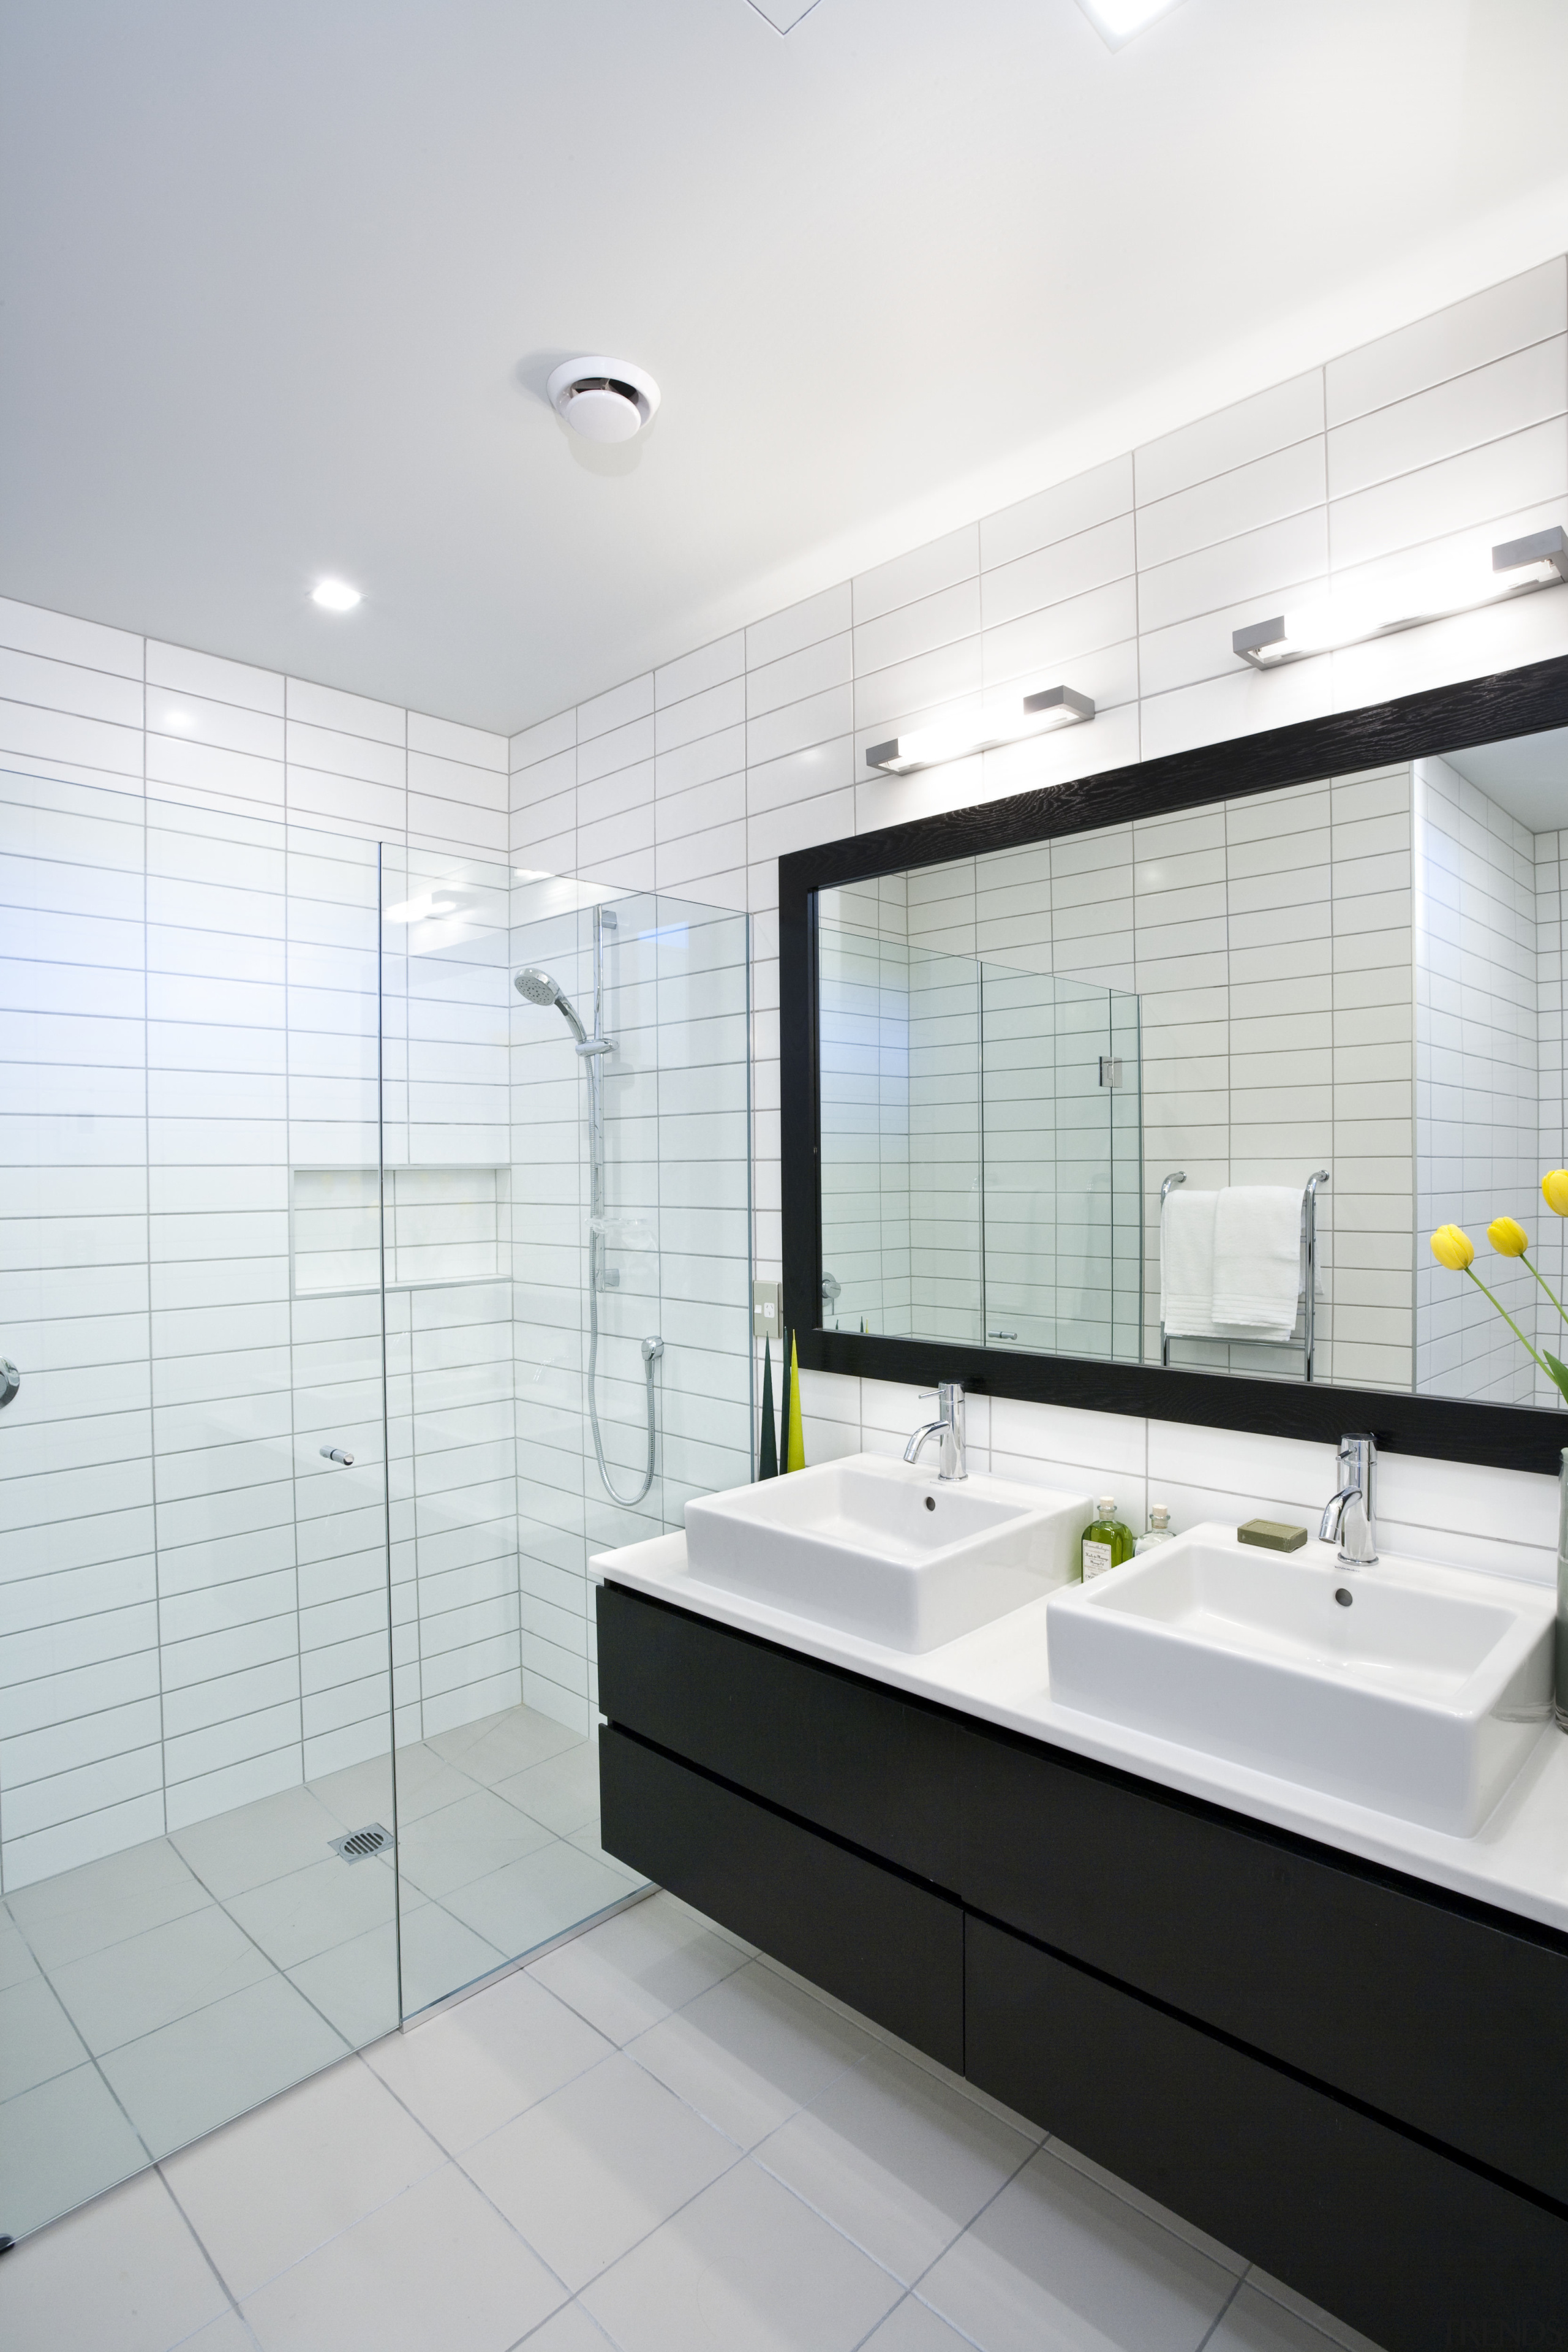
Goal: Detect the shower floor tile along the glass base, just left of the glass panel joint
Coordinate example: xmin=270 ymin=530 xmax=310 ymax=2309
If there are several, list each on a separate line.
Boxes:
xmin=101 ymin=1973 xmax=348 ymax=2157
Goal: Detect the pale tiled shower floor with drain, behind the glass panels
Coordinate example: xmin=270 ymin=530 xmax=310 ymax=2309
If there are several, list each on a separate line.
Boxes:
xmin=0 ymin=1708 xmax=639 ymax=2237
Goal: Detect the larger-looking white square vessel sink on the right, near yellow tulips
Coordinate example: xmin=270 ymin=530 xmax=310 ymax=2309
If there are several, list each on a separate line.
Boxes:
xmin=1046 ymin=1526 xmax=1556 ymax=1837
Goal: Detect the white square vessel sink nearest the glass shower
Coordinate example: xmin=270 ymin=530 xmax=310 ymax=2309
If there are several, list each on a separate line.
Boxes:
xmin=687 ymin=1453 xmax=1093 ymax=1651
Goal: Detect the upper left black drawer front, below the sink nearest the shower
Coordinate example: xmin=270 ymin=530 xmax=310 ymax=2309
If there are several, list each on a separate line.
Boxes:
xmin=600 ymin=1585 xmax=964 ymax=1889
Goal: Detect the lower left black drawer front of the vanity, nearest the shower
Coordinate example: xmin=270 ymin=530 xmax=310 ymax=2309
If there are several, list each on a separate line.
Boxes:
xmin=600 ymin=1728 xmax=964 ymax=2070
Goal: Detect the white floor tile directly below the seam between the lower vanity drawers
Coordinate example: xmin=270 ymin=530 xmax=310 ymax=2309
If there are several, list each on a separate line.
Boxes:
xmin=757 ymin=2051 xmax=1035 ymax=2282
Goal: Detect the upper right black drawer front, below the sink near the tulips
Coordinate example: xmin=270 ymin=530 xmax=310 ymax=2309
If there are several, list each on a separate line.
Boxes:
xmin=959 ymin=1733 xmax=1568 ymax=2201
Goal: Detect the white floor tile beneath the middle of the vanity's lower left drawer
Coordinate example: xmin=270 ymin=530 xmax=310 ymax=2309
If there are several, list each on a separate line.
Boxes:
xmin=628 ymin=1962 xmax=877 ymax=2147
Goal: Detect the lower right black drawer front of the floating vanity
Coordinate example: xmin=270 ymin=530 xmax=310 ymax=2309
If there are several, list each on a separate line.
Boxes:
xmin=964 ymin=1917 xmax=1568 ymax=2352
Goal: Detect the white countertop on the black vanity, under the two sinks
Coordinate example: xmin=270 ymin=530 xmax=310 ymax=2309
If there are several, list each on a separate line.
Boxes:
xmin=590 ymin=1534 xmax=1568 ymax=1933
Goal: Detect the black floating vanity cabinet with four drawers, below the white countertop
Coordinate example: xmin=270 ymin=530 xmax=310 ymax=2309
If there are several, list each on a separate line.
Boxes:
xmin=600 ymin=1583 xmax=1568 ymax=2352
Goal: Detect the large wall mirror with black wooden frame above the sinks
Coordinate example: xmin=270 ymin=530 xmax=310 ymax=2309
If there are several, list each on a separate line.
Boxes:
xmin=780 ymin=658 xmax=1568 ymax=1470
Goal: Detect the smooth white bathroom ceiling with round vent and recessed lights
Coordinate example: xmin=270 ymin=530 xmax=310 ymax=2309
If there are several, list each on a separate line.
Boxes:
xmin=0 ymin=0 xmax=1568 ymax=729
